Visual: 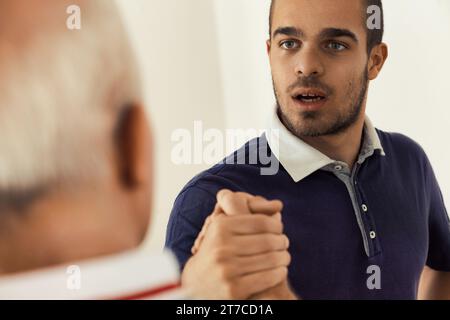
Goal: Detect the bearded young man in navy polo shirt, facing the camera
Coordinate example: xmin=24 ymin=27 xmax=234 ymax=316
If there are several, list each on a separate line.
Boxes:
xmin=166 ymin=0 xmax=450 ymax=299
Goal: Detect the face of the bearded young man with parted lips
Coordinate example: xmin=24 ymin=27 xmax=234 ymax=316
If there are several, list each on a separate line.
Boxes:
xmin=268 ymin=0 xmax=368 ymax=137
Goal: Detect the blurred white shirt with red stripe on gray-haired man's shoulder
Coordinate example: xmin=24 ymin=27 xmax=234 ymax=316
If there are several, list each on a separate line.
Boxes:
xmin=0 ymin=249 xmax=184 ymax=300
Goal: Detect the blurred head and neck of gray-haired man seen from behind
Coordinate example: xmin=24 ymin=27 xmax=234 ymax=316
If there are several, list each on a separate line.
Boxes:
xmin=0 ymin=0 xmax=151 ymax=273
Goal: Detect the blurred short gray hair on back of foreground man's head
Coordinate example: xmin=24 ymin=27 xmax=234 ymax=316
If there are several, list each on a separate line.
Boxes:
xmin=0 ymin=0 xmax=140 ymax=194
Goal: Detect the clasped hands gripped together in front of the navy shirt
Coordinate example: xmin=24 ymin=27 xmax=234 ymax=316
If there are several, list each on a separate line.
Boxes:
xmin=182 ymin=190 xmax=296 ymax=300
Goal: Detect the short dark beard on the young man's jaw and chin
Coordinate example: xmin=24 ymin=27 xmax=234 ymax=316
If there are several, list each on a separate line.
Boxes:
xmin=274 ymin=68 xmax=369 ymax=138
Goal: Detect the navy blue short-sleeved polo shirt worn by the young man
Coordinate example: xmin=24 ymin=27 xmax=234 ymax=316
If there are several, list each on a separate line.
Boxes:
xmin=166 ymin=114 xmax=450 ymax=299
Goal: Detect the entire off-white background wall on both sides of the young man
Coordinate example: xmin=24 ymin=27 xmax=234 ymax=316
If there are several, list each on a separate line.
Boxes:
xmin=119 ymin=0 xmax=450 ymax=248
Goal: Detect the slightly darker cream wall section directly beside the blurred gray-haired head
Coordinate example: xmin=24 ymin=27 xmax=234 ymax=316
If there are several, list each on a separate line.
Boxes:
xmin=118 ymin=0 xmax=225 ymax=249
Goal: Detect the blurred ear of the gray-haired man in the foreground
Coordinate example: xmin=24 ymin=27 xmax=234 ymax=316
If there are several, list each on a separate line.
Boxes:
xmin=116 ymin=104 xmax=153 ymax=189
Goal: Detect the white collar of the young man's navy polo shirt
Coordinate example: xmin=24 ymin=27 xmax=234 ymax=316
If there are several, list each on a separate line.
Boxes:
xmin=266 ymin=110 xmax=386 ymax=182
